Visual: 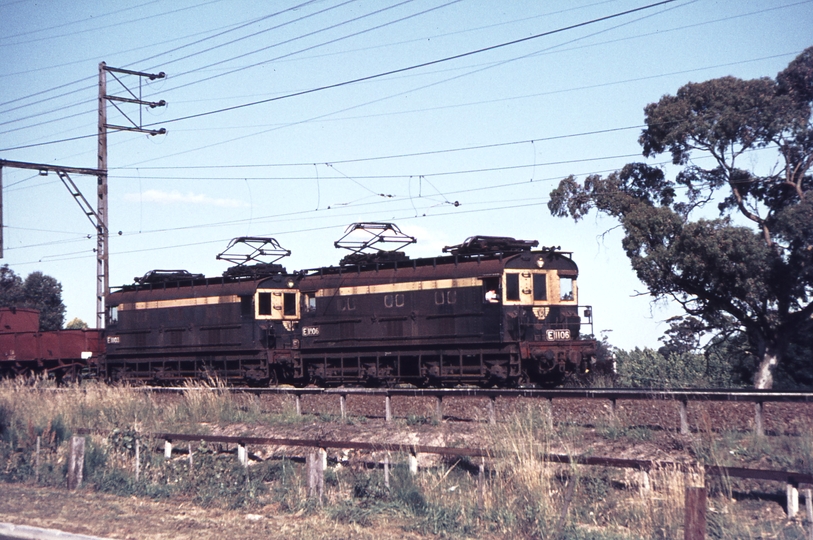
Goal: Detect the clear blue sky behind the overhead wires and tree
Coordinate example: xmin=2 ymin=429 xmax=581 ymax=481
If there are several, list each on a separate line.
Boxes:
xmin=0 ymin=0 xmax=813 ymax=349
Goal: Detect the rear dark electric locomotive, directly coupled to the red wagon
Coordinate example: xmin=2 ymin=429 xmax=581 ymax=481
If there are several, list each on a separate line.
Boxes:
xmin=103 ymin=272 xmax=294 ymax=383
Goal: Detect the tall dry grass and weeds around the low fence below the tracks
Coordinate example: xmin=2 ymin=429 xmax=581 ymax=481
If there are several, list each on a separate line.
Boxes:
xmin=0 ymin=380 xmax=813 ymax=540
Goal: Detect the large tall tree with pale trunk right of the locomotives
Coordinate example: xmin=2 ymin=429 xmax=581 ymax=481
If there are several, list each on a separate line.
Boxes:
xmin=548 ymin=47 xmax=813 ymax=388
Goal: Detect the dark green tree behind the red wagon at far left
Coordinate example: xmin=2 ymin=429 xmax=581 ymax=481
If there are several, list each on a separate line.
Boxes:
xmin=0 ymin=265 xmax=65 ymax=331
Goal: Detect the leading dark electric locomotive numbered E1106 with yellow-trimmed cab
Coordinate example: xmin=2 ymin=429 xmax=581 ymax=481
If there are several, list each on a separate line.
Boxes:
xmin=299 ymin=247 xmax=595 ymax=385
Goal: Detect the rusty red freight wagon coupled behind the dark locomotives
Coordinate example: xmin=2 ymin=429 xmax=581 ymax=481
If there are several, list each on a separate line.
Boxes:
xmin=0 ymin=308 xmax=104 ymax=380
